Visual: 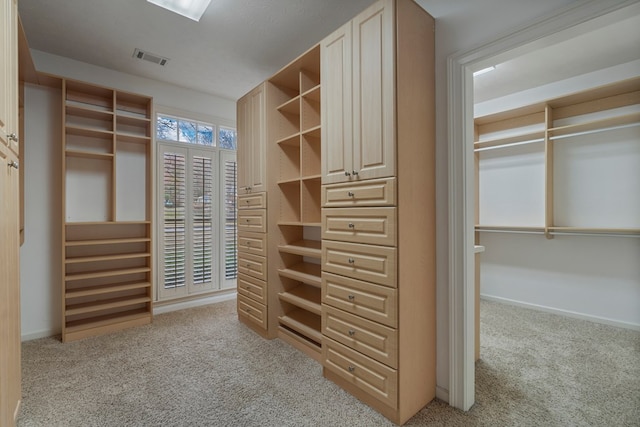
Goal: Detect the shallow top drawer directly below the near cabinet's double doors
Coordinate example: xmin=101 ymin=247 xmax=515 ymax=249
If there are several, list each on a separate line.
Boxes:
xmin=322 ymin=178 xmax=396 ymax=208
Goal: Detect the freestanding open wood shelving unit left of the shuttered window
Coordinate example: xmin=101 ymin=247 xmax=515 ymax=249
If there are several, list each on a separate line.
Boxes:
xmin=62 ymin=79 xmax=153 ymax=342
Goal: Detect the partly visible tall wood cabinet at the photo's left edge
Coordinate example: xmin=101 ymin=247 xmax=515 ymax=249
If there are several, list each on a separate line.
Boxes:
xmin=0 ymin=0 xmax=22 ymax=426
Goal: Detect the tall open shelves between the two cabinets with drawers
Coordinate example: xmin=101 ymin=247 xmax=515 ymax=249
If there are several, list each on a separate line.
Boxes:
xmin=267 ymin=45 xmax=322 ymax=360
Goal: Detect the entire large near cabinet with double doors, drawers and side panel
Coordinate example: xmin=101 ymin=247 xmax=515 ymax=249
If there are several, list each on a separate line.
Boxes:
xmin=321 ymin=0 xmax=436 ymax=424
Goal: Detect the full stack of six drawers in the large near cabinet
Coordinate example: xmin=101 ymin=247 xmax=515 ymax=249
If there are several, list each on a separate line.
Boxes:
xmin=322 ymin=178 xmax=398 ymax=409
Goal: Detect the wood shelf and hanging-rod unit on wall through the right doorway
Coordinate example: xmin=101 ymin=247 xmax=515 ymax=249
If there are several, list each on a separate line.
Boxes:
xmin=474 ymin=78 xmax=640 ymax=238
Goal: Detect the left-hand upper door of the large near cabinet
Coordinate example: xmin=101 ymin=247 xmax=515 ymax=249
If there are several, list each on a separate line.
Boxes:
xmin=320 ymin=22 xmax=353 ymax=184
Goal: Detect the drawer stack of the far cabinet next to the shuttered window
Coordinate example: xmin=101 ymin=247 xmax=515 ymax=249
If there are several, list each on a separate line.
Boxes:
xmin=238 ymin=192 xmax=267 ymax=334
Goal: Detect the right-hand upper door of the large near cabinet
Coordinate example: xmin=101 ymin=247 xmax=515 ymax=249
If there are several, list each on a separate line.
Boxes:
xmin=350 ymin=0 xmax=396 ymax=179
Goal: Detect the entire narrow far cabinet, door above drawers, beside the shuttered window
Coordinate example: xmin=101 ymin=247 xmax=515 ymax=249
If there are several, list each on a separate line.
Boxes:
xmin=237 ymin=83 xmax=269 ymax=336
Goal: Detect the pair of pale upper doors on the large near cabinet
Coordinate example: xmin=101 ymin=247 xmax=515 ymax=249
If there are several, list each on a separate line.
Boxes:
xmin=321 ymin=2 xmax=396 ymax=183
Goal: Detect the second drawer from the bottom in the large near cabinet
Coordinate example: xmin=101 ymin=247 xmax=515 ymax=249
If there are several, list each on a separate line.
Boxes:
xmin=322 ymin=305 xmax=398 ymax=369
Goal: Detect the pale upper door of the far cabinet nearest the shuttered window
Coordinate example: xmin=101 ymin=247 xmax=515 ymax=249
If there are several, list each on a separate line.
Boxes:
xmin=237 ymin=84 xmax=267 ymax=194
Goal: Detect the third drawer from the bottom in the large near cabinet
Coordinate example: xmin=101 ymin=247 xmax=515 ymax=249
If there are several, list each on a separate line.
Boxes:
xmin=322 ymin=272 xmax=398 ymax=328
